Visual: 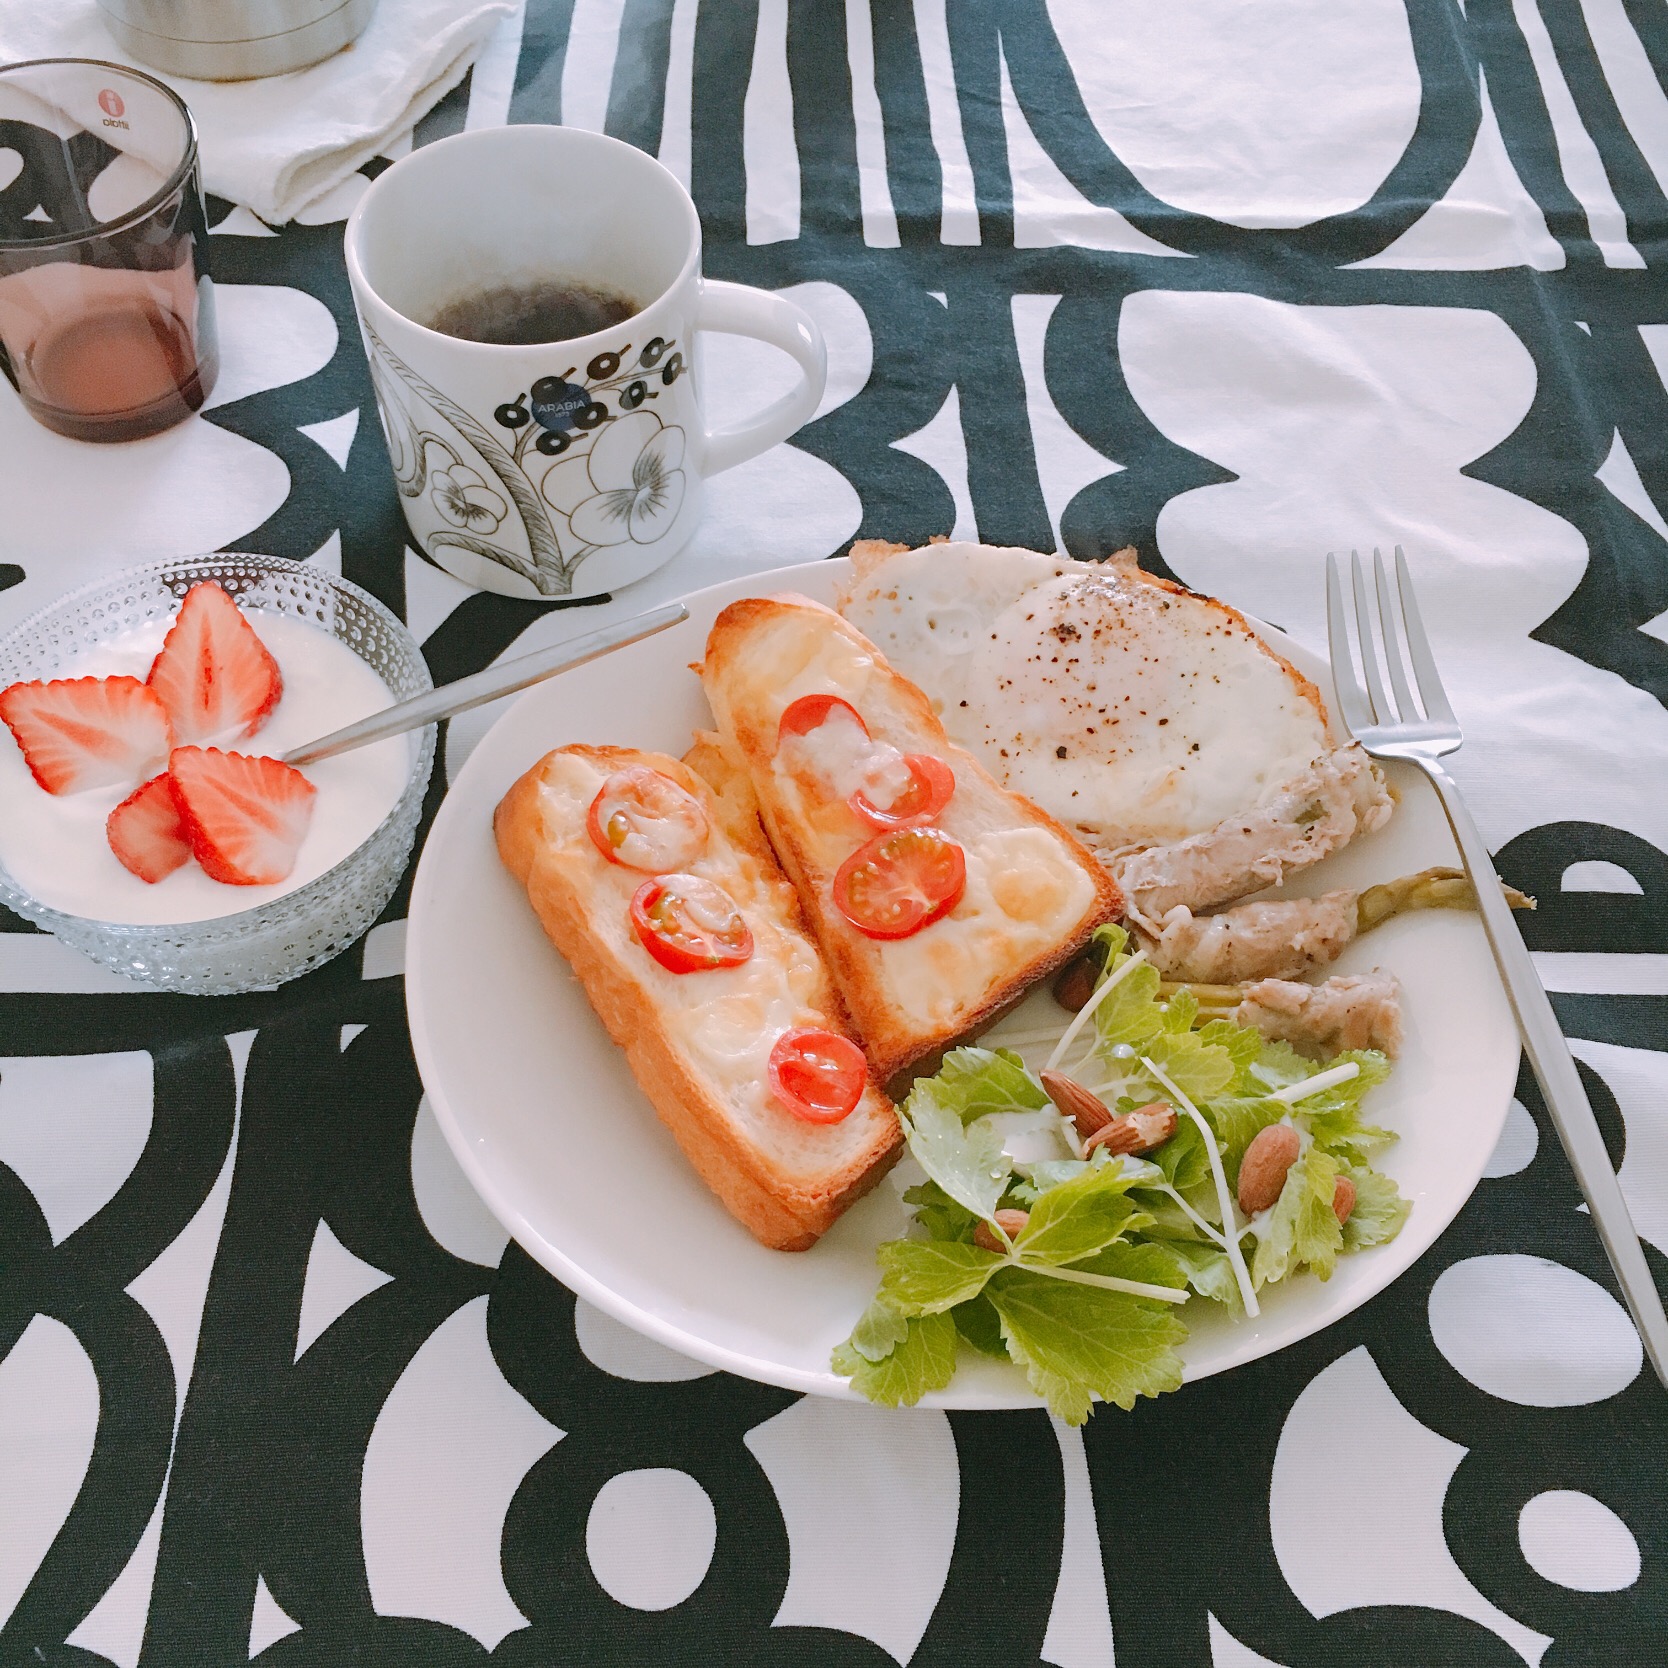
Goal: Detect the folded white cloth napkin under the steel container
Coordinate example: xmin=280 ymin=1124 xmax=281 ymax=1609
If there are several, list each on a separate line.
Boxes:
xmin=0 ymin=0 xmax=515 ymax=225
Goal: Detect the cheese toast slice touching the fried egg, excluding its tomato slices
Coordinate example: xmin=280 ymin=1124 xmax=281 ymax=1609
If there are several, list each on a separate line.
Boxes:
xmin=701 ymin=595 xmax=1123 ymax=1083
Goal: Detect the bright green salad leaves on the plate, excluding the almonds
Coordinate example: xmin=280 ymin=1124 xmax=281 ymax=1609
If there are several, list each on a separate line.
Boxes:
xmin=832 ymin=947 xmax=1409 ymax=1424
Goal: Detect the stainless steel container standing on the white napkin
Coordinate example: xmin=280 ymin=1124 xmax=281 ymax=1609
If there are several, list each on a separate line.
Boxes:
xmin=98 ymin=0 xmax=377 ymax=82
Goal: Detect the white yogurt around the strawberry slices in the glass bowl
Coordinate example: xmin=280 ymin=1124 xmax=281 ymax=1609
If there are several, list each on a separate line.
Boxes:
xmin=0 ymin=609 xmax=415 ymax=926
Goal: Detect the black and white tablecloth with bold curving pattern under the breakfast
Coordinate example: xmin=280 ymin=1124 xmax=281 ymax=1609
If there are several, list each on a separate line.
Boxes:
xmin=0 ymin=0 xmax=1668 ymax=1668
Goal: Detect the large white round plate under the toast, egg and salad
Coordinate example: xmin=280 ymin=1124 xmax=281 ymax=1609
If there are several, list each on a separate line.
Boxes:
xmin=405 ymin=560 xmax=1518 ymax=1408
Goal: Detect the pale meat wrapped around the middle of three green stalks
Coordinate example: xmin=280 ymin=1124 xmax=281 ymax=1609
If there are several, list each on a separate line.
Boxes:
xmin=1139 ymin=891 xmax=1356 ymax=984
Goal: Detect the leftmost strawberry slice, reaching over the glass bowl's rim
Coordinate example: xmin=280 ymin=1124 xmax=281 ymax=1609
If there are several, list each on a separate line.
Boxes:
xmin=0 ymin=677 xmax=173 ymax=794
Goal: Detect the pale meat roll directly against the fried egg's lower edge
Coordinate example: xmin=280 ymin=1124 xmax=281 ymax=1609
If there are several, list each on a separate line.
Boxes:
xmin=1111 ymin=744 xmax=1391 ymax=936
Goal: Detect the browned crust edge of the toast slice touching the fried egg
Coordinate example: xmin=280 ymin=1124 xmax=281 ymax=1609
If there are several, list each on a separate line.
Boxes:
xmin=702 ymin=595 xmax=1123 ymax=1083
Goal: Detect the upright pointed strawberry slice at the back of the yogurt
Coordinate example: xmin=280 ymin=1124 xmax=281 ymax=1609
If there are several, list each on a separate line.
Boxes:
xmin=147 ymin=579 xmax=284 ymax=747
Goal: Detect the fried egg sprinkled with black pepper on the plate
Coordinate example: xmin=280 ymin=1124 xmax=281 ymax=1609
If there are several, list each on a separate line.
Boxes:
xmin=839 ymin=544 xmax=1331 ymax=849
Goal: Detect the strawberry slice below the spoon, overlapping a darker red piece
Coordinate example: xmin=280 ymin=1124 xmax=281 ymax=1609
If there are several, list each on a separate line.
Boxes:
xmin=168 ymin=747 xmax=317 ymax=886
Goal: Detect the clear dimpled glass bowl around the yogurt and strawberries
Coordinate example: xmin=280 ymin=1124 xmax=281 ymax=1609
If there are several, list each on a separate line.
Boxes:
xmin=0 ymin=554 xmax=435 ymax=996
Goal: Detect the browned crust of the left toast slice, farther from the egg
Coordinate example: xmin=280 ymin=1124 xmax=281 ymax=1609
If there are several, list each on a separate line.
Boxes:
xmin=492 ymin=747 xmax=902 ymax=1251
